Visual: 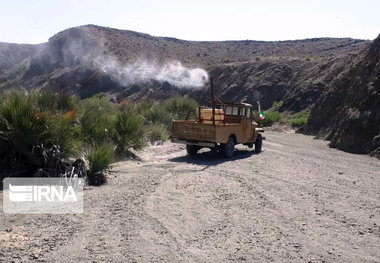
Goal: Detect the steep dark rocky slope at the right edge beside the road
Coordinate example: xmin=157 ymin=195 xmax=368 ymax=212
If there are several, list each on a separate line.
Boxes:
xmin=305 ymin=36 xmax=380 ymax=155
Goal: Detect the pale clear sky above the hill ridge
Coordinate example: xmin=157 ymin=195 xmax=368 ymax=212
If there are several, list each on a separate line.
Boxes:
xmin=0 ymin=0 xmax=380 ymax=43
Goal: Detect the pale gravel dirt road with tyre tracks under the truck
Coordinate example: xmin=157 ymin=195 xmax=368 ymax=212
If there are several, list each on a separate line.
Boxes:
xmin=0 ymin=133 xmax=380 ymax=262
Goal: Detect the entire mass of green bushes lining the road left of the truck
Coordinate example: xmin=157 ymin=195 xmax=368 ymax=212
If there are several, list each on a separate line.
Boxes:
xmin=0 ymin=90 xmax=198 ymax=184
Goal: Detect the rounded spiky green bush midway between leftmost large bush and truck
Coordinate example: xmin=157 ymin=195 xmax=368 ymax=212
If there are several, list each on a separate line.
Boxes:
xmin=112 ymin=109 xmax=144 ymax=155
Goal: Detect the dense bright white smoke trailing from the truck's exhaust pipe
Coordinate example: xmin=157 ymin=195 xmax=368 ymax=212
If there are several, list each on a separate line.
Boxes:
xmin=94 ymin=58 xmax=208 ymax=89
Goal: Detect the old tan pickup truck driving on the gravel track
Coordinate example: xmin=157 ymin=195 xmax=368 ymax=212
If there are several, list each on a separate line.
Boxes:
xmin=172 ymin=102 xmax=264 ymax=158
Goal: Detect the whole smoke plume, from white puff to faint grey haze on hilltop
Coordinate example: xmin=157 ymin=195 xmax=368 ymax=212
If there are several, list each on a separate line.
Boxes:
xmin=51 ymin=28 xmax=208 ymax=89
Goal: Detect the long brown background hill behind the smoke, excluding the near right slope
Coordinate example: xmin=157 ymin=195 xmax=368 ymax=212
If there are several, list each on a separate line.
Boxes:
xmin=0 ymin=25 xmax=368 ymax=106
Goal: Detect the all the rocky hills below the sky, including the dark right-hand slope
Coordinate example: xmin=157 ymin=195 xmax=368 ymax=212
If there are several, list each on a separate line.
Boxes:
xmin=0 ymin=25 xmax=380 ymax=157
